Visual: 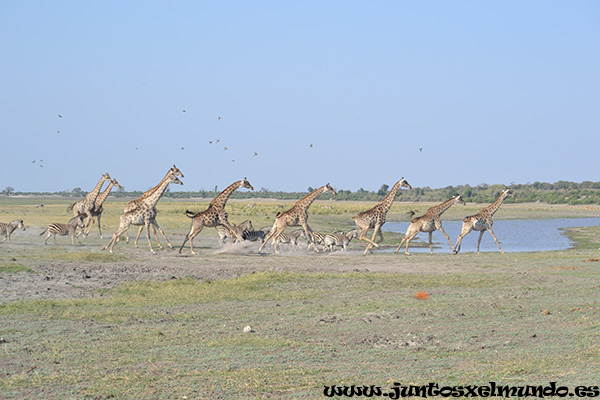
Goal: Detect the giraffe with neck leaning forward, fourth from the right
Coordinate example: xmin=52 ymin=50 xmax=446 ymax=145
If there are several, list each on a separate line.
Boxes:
xmin=258 ymin=183 xmax=337 ymax=254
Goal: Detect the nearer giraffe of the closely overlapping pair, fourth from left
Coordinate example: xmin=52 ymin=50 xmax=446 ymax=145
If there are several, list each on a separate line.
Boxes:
xmin=102 ymin=175 xmax=183 ymax=254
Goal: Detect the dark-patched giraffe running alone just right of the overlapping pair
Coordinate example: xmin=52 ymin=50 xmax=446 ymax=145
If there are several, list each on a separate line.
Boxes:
xmin=179 ymin=178 xmax=254 ymax=254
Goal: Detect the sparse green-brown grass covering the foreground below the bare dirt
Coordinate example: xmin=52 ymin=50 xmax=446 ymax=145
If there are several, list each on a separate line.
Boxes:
xmin=0 ymin=266 xmax=600 ymax=398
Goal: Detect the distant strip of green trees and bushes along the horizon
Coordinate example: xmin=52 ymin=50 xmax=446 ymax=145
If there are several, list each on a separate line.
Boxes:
xmin=4 ymin=181 xmax=600 ymax=205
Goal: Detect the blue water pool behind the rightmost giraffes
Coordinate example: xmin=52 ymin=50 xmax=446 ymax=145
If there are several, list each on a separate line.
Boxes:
xmin=384 ymin=218 xmax=600 ymax=253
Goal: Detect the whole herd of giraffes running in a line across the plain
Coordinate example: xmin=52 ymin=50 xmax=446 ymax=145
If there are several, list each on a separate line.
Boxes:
xmin=28 ymin=165 xmax=511 ymax=255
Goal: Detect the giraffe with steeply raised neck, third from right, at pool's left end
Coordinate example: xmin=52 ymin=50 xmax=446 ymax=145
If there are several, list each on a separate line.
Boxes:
xmin=352 ymin=178 xmax=412 ymax=255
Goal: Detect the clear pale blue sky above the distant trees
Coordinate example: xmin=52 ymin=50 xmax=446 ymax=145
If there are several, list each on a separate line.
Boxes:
xmin=0 ymin=0 xmax=600 ymax=191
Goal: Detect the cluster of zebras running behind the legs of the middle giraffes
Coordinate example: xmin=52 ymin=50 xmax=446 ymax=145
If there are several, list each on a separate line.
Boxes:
xmin=215 ymin=220 xmax=358 ymax=252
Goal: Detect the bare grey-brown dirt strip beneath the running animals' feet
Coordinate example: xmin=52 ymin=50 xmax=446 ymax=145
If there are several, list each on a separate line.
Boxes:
xmin=0 ymin=235 xmax=490 ymax=304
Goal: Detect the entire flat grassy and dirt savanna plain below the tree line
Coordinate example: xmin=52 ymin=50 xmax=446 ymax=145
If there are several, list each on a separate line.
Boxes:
xmin=0 ymin=197 xmax=600 ymax=399
